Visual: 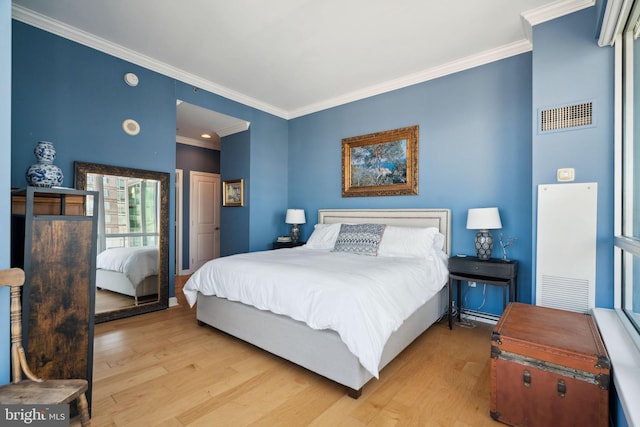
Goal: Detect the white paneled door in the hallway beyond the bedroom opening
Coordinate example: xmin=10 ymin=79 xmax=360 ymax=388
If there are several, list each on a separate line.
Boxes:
xmin=189 ymin=171 xmax=221 ymax=272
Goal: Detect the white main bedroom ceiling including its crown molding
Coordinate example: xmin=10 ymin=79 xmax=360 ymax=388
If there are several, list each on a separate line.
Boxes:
xmin=12 ymin=0 xmax=595 ymax=137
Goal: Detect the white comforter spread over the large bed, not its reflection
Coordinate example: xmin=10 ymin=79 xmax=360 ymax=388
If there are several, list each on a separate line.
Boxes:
xmin=184 ymin=247 xmax=448 ymax=378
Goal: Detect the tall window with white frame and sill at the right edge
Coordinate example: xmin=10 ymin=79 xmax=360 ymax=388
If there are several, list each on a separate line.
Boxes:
xmin=593 ymin=0 xmax=640 ymax=425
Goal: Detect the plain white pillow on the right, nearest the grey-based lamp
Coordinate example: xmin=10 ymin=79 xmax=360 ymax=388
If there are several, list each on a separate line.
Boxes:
xmin=378 ymin=225 xmax=444 ymax=258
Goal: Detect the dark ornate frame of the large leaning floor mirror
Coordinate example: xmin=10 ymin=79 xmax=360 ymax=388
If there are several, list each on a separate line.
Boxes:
xmin=74 ymin=161 xmax=169 ymax=323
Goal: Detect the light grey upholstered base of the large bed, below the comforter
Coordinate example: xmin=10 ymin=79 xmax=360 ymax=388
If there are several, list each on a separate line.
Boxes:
xmin=197 ymin=286 xmax=448 ymax=397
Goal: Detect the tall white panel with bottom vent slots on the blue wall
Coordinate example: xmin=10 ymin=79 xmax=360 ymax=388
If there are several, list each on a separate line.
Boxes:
xmin=536 ymin=182 xmax=598 ymax=313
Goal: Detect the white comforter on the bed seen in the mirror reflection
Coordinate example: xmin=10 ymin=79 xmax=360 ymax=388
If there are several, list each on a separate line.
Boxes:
xmin=96 ymin=246 xmax=158 ymax=286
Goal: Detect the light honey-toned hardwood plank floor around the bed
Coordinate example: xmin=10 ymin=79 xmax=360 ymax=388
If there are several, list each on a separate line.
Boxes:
xmin=80 ymin=282 xmax=502 ymax=427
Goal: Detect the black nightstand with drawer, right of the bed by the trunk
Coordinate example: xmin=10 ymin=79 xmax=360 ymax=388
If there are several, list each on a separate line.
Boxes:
xmin=449 ymin=256 xmax=518 ymax=329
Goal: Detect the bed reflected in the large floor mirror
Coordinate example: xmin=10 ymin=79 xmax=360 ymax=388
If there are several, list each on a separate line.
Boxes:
xmin=96 ymin=246 xmax=158 ymax=305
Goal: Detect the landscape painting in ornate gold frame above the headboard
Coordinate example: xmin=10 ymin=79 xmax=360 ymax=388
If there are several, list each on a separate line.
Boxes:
xmin=342 ymin=125 xmax=419 ymax=197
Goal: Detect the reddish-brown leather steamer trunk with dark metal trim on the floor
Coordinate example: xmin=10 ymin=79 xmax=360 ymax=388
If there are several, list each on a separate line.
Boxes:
xmin=490 ymin=302 xmax=610 ymax=427
